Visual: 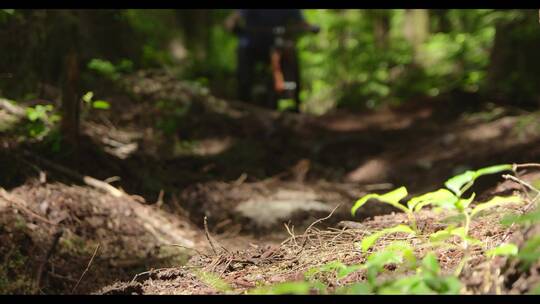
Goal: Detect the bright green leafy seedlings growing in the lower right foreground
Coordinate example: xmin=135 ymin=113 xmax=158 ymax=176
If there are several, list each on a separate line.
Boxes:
xmin=250 ymin=165 xmax=540 ymax=294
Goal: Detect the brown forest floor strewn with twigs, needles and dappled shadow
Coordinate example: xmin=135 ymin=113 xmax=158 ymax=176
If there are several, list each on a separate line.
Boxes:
xmin=0 ymin=71 xmax=540 ymax=294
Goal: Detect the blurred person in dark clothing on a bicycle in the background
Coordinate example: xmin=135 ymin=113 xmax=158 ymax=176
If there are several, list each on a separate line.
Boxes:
xmin=226 ymin=9 xmax=318 ymax=110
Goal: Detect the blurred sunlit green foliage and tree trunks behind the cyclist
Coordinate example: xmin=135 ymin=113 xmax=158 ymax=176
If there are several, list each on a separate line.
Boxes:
xmin=0 ymin=9 xmax=540 ymax=114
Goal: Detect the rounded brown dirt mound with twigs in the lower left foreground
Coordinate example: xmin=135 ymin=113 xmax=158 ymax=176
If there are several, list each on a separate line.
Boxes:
xmin=0 ymin=181 xmax=205 ymax=294
